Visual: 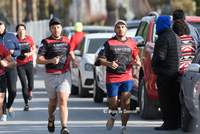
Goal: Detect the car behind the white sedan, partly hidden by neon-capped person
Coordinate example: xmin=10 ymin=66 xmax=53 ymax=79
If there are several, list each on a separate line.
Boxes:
xmin=61 ymin=26 xmax=114 ymax=40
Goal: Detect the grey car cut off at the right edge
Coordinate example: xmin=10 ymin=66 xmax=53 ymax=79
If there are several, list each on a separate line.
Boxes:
xmin=180 ymin=51 xmax=200 ymax=132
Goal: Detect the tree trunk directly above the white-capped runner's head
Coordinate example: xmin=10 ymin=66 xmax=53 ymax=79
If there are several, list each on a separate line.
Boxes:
xmin=105 ymin=0 xmax=117 ymax=26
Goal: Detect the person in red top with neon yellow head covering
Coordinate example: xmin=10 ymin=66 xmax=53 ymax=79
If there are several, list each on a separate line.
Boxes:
xmin=70 ymin=22 xmax=86 ymax=51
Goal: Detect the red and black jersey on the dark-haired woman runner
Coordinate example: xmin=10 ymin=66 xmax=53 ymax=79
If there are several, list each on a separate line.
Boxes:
xmin=17 ymin=35 xmax=35 ymax=66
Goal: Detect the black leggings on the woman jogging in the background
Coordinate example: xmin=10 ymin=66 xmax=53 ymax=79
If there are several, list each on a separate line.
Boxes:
xmin=17 ymin=61 xmax=34 ymax=104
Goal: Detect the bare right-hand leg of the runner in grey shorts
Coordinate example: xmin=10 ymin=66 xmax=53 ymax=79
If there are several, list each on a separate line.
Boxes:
xmin=57 ymin=92 xmax=69 ymax=127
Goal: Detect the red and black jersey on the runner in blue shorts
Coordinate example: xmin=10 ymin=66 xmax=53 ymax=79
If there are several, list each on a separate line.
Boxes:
xmin=98 ymin=37 xmax=139 ymax=83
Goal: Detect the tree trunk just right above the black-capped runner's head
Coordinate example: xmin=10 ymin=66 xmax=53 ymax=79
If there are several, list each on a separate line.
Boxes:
xmin=63 ymin=0 xmax=73 ymax=26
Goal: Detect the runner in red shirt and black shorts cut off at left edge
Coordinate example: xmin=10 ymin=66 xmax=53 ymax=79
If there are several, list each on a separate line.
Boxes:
xmin=0 ymin=44 xmax=15 ymax=118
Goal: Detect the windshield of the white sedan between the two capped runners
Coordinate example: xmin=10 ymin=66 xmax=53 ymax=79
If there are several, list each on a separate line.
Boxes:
xmin=86 ymin=38 xmax=109 ymax=54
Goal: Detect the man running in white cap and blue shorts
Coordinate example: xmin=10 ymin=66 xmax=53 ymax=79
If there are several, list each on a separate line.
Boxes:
xmin=95 ymin=20 xmax=141 ymax=134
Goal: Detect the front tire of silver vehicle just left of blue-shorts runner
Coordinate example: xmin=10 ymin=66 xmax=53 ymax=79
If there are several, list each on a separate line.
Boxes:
xmin=93 ymin=78 xmax=104 ymax=103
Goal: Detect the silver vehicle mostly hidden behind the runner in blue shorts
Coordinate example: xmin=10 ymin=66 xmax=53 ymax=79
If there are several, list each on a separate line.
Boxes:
xmin=93 ymin=28 xmax=137 ymax=103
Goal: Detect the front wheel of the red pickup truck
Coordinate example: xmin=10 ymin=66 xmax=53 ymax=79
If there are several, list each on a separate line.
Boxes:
xmin=139 ymin=77 xmax=158 ymax=119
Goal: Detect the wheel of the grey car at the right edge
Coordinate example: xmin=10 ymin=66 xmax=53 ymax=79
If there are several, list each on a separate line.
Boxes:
xmin=181 ymin=96 xmax=197 ymax=132
